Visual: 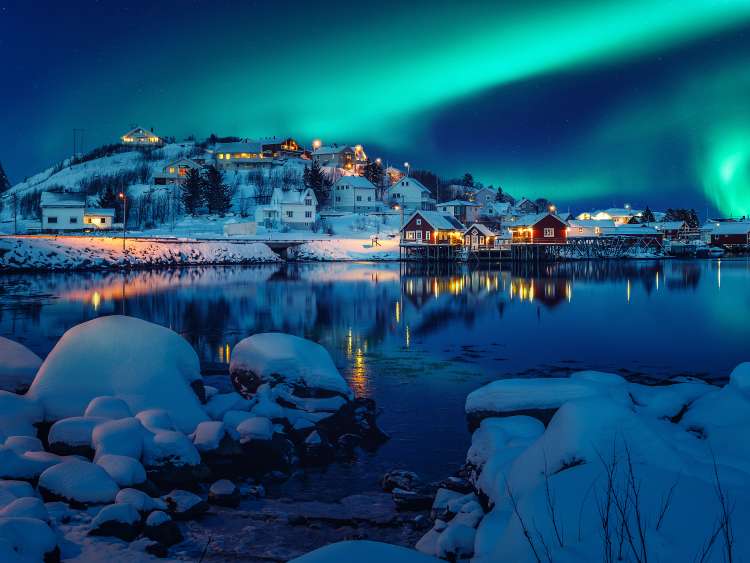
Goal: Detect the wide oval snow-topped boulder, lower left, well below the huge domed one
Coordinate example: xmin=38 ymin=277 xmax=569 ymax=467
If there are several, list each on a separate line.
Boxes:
xmin=39 ymin=459 xmax=120 ymax=506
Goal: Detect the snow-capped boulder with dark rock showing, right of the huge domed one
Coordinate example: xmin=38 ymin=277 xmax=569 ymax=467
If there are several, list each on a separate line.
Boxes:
xmin=229 ymin=333 xmax=353 ymax=399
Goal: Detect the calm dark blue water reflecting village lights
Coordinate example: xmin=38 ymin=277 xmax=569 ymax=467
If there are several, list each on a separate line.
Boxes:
xmin=0 ymin=259 xmax=750 ymax=496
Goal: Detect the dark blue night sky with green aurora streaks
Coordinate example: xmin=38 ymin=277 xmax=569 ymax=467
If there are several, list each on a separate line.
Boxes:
xmin=0 ymin=0 xmax=750 ymax=215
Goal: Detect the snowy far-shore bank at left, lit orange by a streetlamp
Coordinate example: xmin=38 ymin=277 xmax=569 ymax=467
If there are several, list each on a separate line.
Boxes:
xmin=0 ymin=236 xmax=281 ymax=271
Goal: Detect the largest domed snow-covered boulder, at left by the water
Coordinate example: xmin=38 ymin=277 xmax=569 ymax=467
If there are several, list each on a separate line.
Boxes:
xmin=28 ymin=315 xmax=207 ymax=432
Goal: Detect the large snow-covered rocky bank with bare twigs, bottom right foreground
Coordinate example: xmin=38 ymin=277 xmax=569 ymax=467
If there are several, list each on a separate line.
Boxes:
xmin=450 ymin=364 xmax=750 ymax=563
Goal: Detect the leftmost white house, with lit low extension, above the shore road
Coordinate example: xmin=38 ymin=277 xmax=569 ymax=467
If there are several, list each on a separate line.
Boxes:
xmin=41 ymin=192 xmax=115 ymax=231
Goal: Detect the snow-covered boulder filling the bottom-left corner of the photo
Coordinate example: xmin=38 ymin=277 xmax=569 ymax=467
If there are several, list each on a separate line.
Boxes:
xmin=0 ymin=517 xmax=60 ymax=563
